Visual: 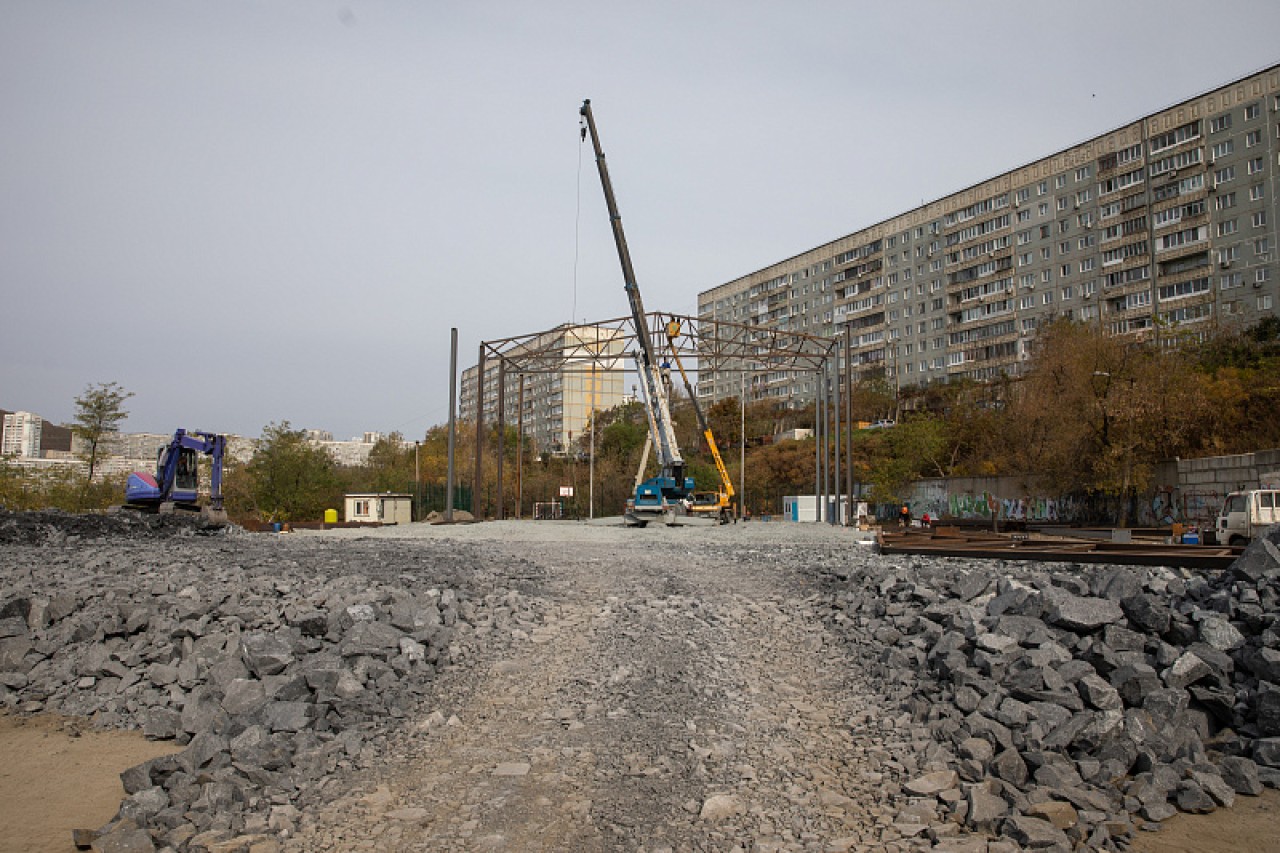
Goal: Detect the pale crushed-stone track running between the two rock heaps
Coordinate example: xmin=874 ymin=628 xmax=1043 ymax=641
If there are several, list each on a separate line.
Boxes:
xmin=284 ymin=534 xmax=901 ymax=850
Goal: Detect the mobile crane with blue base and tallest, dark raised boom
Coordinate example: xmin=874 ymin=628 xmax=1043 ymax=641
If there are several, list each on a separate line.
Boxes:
xmin=579 ymin=100 xmax=694 ymax=528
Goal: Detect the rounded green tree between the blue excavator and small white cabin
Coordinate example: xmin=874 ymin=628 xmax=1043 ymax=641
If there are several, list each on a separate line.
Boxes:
xmin=243 ymin=420 xmax=342 ymax=521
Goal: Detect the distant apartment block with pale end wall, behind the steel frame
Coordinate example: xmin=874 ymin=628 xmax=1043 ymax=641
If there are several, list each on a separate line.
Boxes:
xmin=458 ymin=325 xmax=626 ymax=456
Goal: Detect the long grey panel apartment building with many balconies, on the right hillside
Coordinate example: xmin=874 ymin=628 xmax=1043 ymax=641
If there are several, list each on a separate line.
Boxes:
xmin=698 ymin=65 xmax=1280 ymax=402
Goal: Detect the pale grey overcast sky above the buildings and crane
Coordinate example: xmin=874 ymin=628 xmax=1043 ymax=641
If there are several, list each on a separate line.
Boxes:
xmin=0 ymin=0 xmax=1280 ymax=438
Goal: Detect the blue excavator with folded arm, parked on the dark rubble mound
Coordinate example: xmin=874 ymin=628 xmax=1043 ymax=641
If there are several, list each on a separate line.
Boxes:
xmin=124 ymin=429 xmax=228 ymax=526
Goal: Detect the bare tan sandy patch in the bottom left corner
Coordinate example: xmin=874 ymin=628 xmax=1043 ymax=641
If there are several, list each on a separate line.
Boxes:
xmin=0 ymin=715 xmax=178 ymax=853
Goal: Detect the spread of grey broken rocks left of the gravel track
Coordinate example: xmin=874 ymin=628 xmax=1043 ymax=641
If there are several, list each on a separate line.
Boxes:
xmin=0 ymin=514 xmax=540 ymax=850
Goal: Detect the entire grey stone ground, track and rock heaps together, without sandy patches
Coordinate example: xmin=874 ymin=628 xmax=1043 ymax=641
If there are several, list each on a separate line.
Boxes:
xmin=0 ymin=512 xmax=1280 ymax=853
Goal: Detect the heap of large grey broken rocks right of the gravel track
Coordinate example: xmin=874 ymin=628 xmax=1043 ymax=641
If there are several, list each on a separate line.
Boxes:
xmin=823 ymin=528 xmax=1280 ymax=852
